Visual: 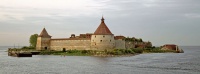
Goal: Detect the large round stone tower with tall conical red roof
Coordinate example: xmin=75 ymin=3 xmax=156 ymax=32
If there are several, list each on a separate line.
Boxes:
xmin=91 ymin=16 xmax=115 ymax=50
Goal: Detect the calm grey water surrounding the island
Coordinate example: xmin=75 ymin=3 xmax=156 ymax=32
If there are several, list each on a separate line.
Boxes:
xmin=0 ymin=47 xmax=200 ymax=74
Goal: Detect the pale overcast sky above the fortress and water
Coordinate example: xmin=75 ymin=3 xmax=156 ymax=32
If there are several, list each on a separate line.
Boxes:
xmin=0 ymin=0 xmax=200 ymax=46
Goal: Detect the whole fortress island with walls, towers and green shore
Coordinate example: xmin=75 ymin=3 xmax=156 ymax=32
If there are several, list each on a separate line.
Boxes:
xmin=8 ymin=17 xmax=183 ymax=57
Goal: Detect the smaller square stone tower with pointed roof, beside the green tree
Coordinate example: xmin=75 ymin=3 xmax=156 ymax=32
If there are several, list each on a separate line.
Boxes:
xmin=36 ymin=28 xmax=51 ymax=50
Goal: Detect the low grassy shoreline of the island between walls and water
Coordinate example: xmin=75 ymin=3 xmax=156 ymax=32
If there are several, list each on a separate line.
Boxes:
xmin=7 ymin=49 xmax=180 ymax=57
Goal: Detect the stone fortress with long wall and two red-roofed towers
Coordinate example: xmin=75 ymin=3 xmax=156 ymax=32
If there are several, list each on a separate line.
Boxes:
xmin=36 ymin=17 xmax=151 ymax=51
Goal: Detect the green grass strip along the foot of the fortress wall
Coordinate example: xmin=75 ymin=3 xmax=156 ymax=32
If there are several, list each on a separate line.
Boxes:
xmin=40 ymin=49 xmax=135 ymax=56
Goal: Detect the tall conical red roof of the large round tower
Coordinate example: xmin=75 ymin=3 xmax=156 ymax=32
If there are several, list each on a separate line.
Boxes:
xmin=94 ymin=17 xmax=112 ymax=35
